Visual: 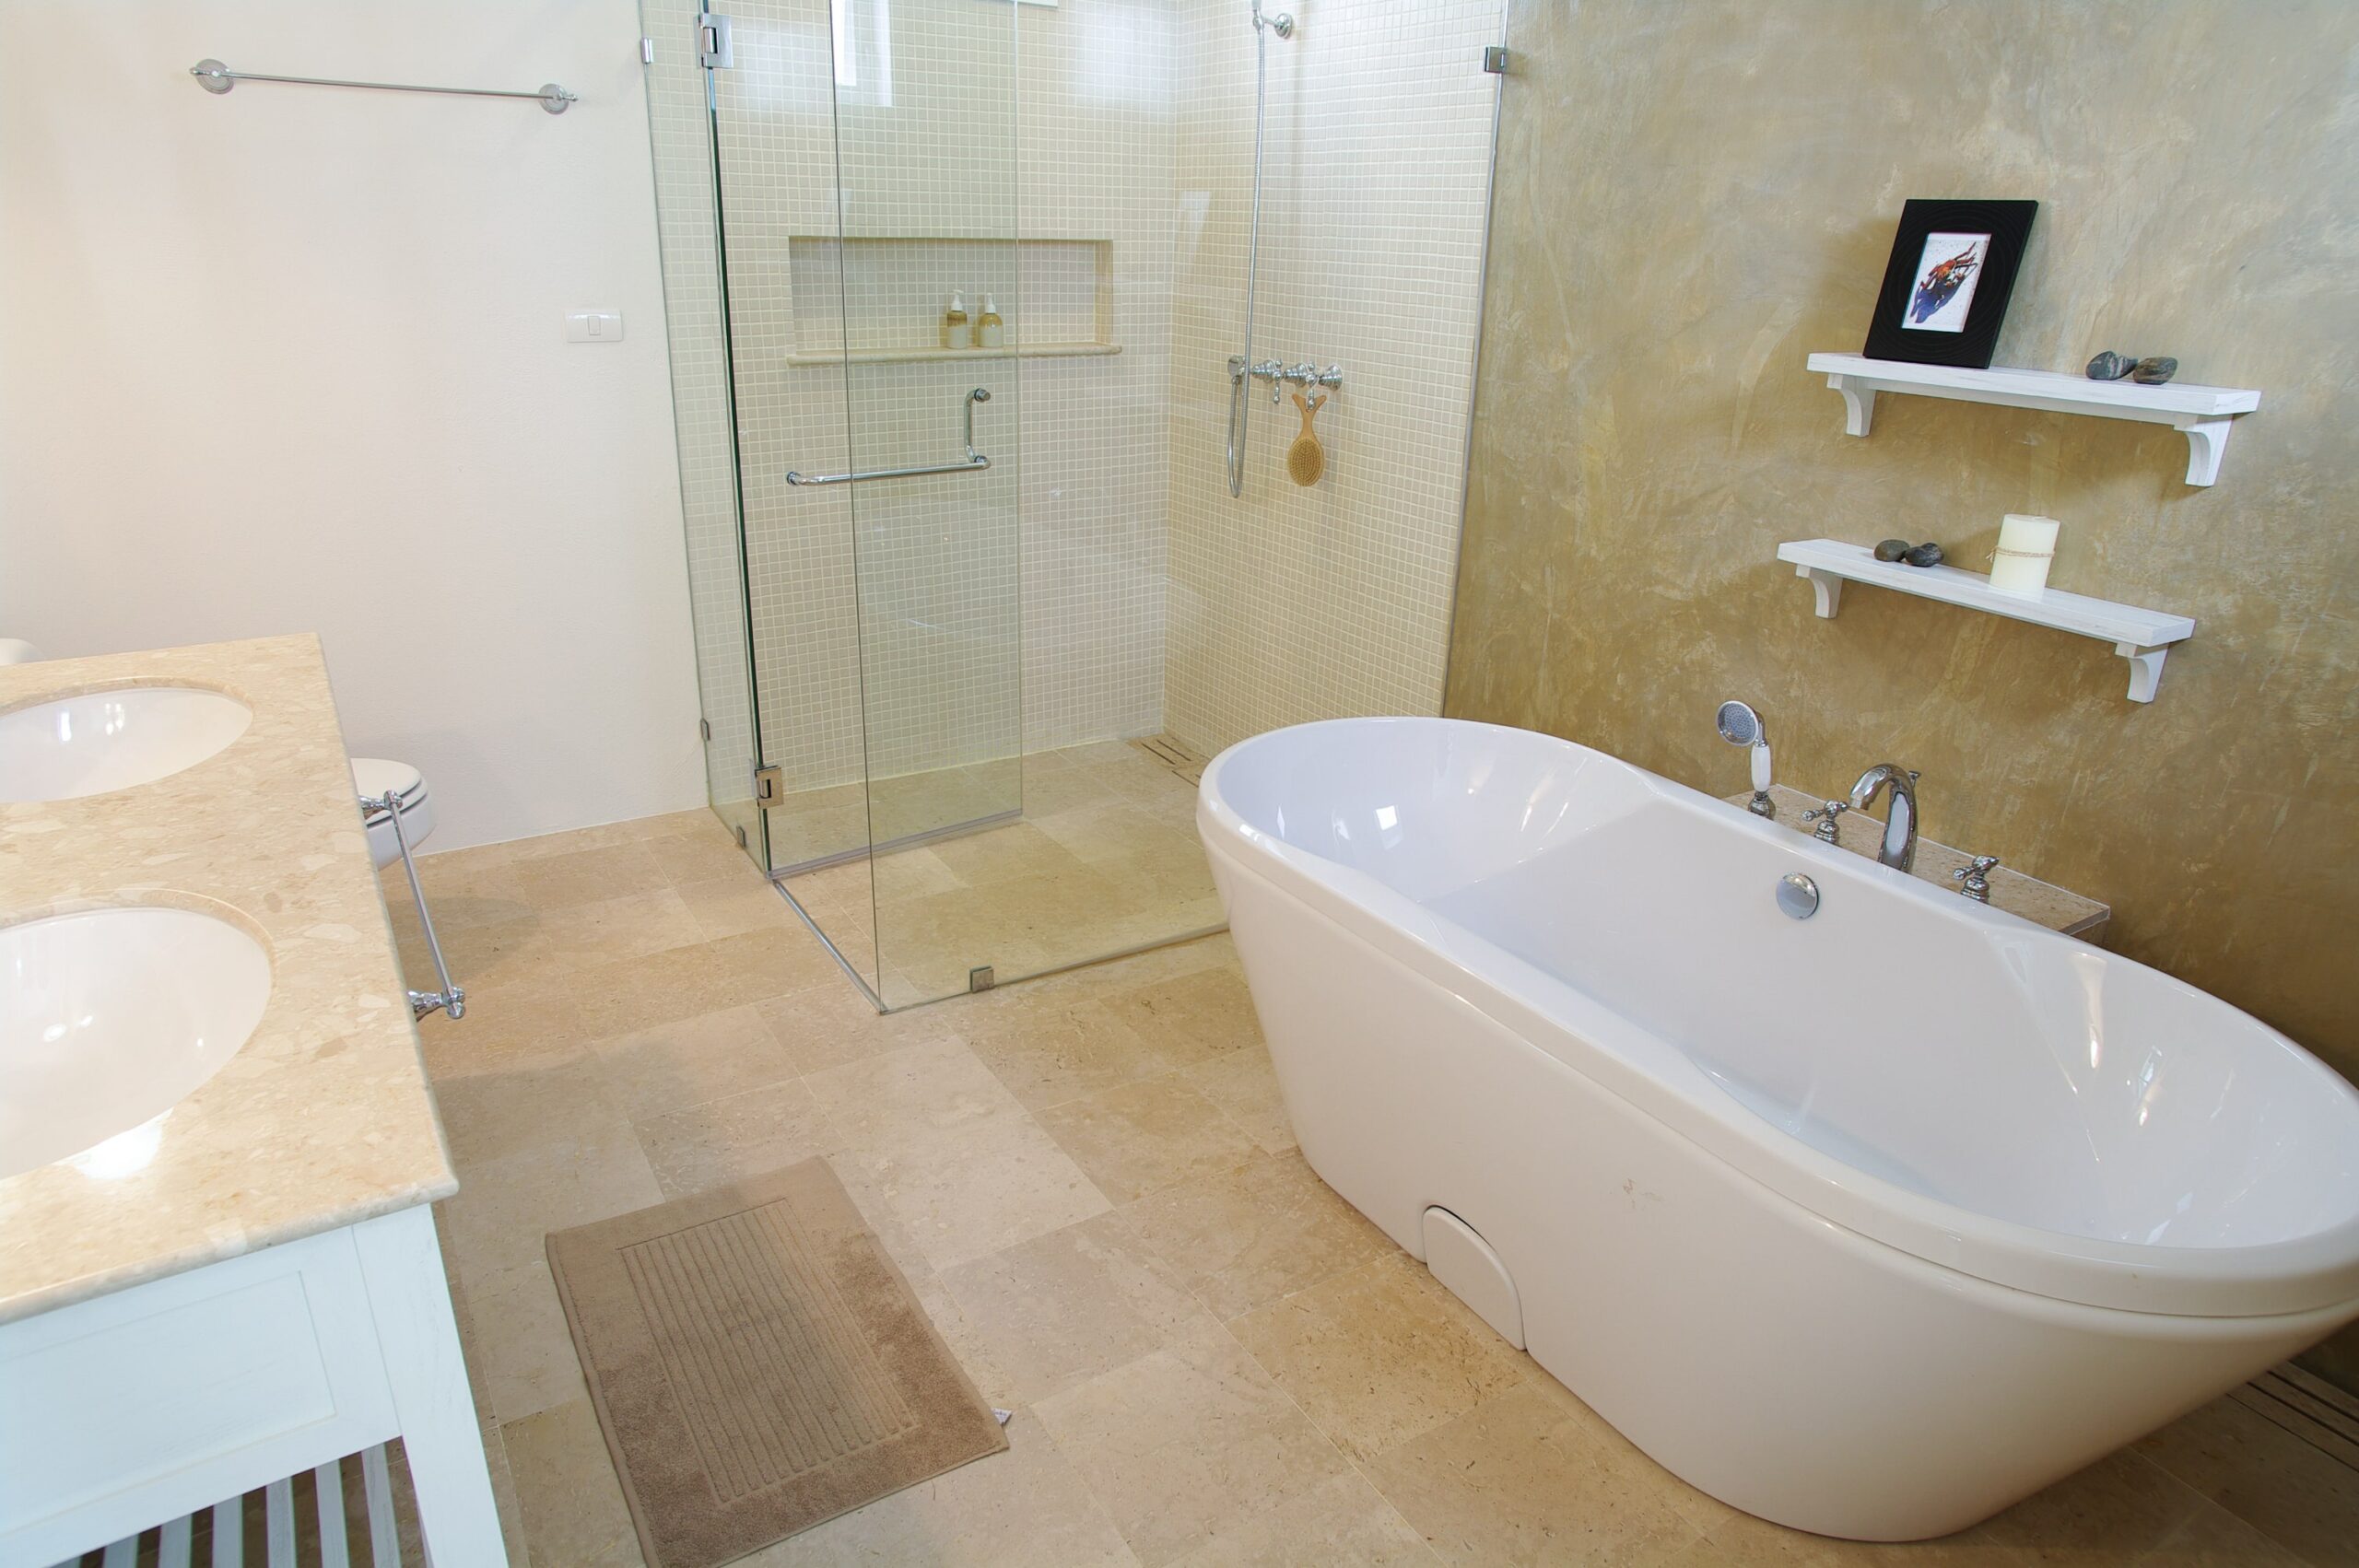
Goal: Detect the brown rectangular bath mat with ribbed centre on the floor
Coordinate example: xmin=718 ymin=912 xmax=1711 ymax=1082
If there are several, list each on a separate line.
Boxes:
xmin=549 ymin=1160 xmax=1007 ymax=1568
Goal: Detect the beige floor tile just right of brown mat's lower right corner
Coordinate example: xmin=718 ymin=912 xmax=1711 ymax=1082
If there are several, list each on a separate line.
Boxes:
xmin=1038 ymin=1335 xmax=1349 ymax=1568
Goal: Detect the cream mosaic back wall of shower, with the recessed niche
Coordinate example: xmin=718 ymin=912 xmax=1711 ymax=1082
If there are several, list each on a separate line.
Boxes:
xmin=717 ymin=0 xmax=1172 ymax=863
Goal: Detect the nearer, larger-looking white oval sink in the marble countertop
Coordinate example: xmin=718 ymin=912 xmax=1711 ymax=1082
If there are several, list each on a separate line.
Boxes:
xmin=0 ymin=906 xmax=271 ymax=1176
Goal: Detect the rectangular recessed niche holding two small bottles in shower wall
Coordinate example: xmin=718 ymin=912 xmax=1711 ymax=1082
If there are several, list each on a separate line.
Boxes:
xmin=788 ymin=233 xmax=1121 ymax=366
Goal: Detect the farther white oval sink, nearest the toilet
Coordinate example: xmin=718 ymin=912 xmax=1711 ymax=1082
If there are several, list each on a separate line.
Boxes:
xmin=0 ymin=686 xmax=254 ymax=800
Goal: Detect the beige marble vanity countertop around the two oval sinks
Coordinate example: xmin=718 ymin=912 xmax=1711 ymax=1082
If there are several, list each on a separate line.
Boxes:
xmin=0 ymin=634 xmax=458 ymax=1323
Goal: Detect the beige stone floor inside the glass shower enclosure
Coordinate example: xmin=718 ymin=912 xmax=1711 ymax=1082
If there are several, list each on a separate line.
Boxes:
xmin=769 ymin=741 xmax=1220 ymax=1007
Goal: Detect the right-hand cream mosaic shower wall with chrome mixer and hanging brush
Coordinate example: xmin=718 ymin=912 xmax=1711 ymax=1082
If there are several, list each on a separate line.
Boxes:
xmin=1166 ymin=0 xmax=1503 ymax=752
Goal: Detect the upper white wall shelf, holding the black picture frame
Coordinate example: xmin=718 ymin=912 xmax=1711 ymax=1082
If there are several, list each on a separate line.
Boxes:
xmin=1810 ymin=354 xmax=2259 ymax=486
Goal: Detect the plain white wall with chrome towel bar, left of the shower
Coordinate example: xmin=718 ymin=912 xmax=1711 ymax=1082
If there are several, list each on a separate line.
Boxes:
xmin=0 ymin=0 xmax=705 ymax=848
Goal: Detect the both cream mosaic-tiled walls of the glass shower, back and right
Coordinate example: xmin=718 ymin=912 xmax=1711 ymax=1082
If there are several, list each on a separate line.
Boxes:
xmin=651 ymin=0 xmax=1500 ymax=865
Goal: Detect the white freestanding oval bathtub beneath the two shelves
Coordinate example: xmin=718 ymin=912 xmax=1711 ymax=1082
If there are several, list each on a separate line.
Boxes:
xmin=1198 ymin=720 xmax=2359 ymax=1539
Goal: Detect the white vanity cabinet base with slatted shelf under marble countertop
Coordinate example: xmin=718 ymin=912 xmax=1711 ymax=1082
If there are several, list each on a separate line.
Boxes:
xmin=0 ymin=1205 xmax=507 ymax=1568
